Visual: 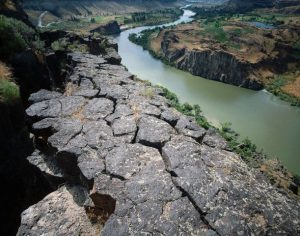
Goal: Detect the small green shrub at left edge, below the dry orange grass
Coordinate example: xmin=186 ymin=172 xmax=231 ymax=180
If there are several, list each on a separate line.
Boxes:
xmin=0 ymin=80 xmax=20 ymax=103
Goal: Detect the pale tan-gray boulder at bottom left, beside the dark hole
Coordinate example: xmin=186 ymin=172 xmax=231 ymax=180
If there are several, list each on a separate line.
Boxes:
xmin=17 ymin=186 xmax=101 ymax=236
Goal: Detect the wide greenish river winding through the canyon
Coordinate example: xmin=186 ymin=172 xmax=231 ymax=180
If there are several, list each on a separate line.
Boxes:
xmin=115 ymin=10 xmax=300 ymax=174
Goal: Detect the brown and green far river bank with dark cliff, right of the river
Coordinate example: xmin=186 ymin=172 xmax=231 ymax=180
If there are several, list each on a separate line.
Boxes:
xmin=129 ymin=9 xmax=300 ymax=106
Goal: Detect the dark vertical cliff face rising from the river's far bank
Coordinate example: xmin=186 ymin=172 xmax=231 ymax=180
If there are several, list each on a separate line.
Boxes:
xmin=161 ymin=37 xmax=263 ymax=90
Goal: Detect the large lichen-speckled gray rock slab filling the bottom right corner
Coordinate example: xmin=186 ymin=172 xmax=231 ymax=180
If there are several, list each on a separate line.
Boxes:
xmin=163 ymin=139 xmax=299 ymax=235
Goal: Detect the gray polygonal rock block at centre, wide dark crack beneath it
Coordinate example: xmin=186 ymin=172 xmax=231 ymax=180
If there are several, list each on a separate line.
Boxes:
xmin=136 ymin=116 xmax=176 ymax=147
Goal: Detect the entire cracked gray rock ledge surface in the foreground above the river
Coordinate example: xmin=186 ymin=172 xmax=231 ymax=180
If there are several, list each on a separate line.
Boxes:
xmin=18 ymin=52 xmax=300 ymax=236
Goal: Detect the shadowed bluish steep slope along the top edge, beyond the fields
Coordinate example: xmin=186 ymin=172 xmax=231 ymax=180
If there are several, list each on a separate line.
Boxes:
xmin=23 ymin=0 xmax=179 ymax=24
